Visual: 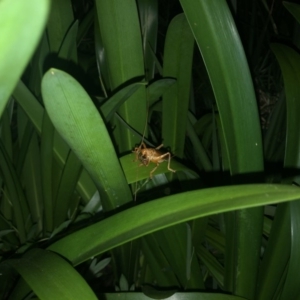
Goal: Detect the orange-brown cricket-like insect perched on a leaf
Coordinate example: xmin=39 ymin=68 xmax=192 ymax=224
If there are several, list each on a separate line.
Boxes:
xmin=132 ymin=142 xmax=176 ymax=178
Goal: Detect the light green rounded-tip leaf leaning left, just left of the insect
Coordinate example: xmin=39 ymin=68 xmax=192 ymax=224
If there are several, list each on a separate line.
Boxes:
xmin=42 ymin=69 xmax=131 ymax=210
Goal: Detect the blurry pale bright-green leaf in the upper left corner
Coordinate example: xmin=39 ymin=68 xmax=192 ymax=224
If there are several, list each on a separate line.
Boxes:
xmin=0 ymin=0 xmax=49 ymax=116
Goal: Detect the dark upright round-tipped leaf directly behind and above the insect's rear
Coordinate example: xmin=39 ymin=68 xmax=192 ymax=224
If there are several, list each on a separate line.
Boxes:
xmin=162 ymin=14 xmax=194 ymax=158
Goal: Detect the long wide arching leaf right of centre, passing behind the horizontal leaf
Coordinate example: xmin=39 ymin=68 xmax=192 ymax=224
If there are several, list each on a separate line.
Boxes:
xmin=180 ymin=0 xmax=263 ymax=299
